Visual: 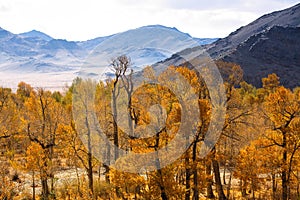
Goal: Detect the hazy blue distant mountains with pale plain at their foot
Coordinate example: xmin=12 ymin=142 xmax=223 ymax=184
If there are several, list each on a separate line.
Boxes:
xmin=0 ymin=25 xmax=215 ymax=88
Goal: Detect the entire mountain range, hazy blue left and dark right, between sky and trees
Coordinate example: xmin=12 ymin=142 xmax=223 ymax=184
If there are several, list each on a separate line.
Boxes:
xmin=0 ymin=4 xmax=300 ymax=88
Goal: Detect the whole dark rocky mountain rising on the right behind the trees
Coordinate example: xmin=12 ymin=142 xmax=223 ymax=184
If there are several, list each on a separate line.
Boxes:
xmin=157 ymin=4 xmax=300 ymax=88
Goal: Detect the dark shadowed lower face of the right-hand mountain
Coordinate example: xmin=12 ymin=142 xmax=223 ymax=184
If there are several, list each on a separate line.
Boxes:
xmin=222 ymin=26 xmax=300 ymax=88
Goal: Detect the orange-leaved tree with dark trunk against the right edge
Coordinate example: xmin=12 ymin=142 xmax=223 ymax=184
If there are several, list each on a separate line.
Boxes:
xmin=264 ymin=87 xmax=300 ymax=200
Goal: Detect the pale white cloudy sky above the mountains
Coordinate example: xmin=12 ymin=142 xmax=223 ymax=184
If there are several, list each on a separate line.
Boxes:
xmin=0 ymin=0 xmax=299 ymax=41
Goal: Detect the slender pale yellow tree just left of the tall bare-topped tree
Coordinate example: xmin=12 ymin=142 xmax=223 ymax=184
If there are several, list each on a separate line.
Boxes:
xmin=72 ymin=79 xmax=96 ymax=193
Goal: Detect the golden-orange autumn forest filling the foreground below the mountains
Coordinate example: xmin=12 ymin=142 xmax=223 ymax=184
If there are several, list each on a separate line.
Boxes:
xmin=0 ymin=56 xmax=300 ymax=200
